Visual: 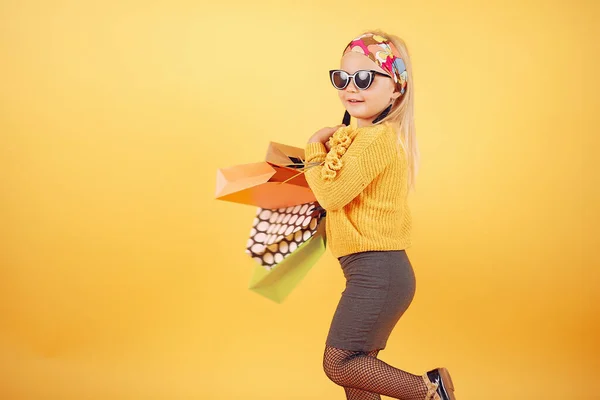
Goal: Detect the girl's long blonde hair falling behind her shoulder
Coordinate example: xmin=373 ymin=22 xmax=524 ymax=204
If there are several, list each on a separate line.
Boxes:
xmin=357 ymin=29 xmax=420 ymax=190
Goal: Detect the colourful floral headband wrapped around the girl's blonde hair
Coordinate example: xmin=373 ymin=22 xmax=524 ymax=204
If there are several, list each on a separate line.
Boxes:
xmin=342 ymin=33 xmax=408 ymax=94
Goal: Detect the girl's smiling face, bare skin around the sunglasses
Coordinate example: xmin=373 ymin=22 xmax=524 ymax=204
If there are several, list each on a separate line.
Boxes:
xmin=338 ymin=52 xmax=400 ymax=127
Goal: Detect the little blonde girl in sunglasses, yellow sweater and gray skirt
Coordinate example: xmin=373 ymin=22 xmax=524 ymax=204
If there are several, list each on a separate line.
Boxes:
xmin=305 ymin=31 xmax=455 ymax=400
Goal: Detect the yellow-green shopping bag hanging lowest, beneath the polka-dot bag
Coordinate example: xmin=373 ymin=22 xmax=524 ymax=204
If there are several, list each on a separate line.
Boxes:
xmin=249 ymin=212 xmax=327 ymax=303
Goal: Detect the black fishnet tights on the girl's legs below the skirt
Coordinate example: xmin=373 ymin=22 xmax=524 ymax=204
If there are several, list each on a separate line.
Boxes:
xmin=323 ymin=346 xmax=427 ymax=400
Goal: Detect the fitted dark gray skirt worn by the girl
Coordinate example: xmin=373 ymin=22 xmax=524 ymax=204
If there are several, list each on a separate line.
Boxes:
xmin=326 ymin=250 xmax=416 ymax=352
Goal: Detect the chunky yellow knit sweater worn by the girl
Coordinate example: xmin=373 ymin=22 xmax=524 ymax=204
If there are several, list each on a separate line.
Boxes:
xmin=305 ymin=123 xmax=412 ymax=257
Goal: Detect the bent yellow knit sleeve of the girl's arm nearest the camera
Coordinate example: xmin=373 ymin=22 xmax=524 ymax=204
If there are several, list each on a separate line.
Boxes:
xmin=305 ymin=126 xmax=398 ymax=211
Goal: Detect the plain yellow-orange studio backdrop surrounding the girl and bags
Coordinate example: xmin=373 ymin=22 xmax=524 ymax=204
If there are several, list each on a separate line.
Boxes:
xmin=0 ymin=0 xmax=600 ymax=400
